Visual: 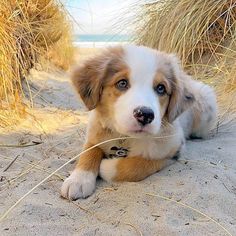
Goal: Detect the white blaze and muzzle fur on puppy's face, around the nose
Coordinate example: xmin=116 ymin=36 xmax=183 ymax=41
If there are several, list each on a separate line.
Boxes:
xmin=112 ymin=45 xmax=161 ymax=135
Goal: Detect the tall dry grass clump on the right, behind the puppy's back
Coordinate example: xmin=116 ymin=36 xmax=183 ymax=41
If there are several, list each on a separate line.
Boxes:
xmin=135 ymin=0 xmax=236 ymax=121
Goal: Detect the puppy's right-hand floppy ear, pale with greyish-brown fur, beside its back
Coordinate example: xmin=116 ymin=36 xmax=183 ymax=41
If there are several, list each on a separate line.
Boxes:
xmin=167 ymin=55 xmax=195 ymax=123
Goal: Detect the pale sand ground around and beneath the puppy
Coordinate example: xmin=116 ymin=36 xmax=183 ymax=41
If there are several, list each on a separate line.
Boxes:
xmin=0 ymin=48 xmax=236 ymax=236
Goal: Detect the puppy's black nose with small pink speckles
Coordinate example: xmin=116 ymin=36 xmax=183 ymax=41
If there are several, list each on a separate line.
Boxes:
xmin=133 ymin=107 xmax=154 ymax=126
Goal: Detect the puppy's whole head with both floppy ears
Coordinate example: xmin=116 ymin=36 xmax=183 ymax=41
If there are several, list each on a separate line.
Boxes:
xmin=72 ymin=45 xmax=194 ymax=136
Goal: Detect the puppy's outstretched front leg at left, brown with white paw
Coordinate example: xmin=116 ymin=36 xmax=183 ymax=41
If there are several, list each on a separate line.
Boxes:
xmin=61 ymin=144 xmax=104 ymax=200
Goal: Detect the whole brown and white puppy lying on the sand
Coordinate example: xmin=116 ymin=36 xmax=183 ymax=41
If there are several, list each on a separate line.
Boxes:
xmin=61 ymin=45 xmax=216 ymax=200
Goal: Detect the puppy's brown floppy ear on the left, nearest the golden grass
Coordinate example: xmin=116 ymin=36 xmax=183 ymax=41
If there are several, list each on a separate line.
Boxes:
xmin=72 ymin=55 xmax=109 ymax=110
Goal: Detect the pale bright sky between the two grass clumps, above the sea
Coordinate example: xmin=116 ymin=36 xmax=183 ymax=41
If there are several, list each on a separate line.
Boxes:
xmin=62 ymin=0 xmax=140 ymax=34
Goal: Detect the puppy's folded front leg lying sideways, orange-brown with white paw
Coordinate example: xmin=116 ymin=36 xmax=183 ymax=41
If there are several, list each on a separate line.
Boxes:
xmin=99 ymin=157 xmax=170 ymax=182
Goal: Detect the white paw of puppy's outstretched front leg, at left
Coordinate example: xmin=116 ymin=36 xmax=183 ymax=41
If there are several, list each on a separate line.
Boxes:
xmin=61 ymin=170 xmax=96 ymax=200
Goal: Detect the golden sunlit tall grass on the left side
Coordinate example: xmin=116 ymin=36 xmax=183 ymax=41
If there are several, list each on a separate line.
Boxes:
xmin=0 ymin=0 xmax=72 ymax=126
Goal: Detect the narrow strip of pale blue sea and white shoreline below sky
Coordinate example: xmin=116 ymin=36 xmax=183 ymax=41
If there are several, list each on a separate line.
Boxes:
xmin=73 ymin=34 xmax=132 ymax=48
